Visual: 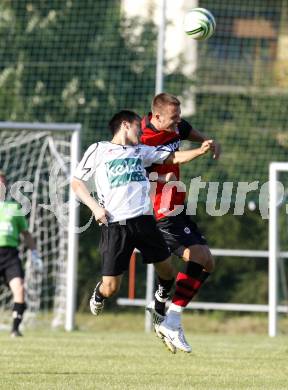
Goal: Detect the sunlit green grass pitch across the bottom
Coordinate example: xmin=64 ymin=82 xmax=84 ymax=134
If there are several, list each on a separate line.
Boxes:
xmin=0 ymin=313 xmax=288 ymax=390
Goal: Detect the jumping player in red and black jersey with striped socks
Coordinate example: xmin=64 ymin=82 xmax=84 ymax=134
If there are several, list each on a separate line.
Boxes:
xmin=141 ymin=93 xmax=220 ymax=352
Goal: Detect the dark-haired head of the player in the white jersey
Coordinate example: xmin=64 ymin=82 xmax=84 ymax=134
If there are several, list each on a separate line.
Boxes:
xmin=109 ymin=110 xmax=141 ymax=145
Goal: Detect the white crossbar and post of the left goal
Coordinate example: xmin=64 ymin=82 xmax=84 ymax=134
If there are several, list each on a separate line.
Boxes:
xmin=0 ymin=122 xmax=82 ymax=331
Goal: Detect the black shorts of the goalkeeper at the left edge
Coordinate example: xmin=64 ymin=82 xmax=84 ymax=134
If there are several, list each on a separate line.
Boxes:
xmin=0 ymin=247 xmax=24 ymax=284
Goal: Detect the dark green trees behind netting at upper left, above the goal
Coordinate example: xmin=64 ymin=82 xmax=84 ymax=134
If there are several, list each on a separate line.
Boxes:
xmin=0 ymin=0 xmax=156 ymax=146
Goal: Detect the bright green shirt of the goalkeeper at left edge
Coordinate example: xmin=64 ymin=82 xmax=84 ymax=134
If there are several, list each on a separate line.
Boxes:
xmin=0 ymin=201 xmax=28 ymax=248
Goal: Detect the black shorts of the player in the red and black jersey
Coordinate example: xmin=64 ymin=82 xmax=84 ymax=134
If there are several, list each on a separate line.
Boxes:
xmin=157 ymin=212 xmax=207 ymax=257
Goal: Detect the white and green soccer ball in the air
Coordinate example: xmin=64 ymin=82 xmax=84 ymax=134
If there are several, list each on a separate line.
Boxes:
xmin=184 ymin=8 xmax=216 ymax=41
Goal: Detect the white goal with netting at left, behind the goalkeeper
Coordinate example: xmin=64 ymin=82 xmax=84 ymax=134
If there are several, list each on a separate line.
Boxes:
xmin=0 ymin=122 xmax=80 ymax=327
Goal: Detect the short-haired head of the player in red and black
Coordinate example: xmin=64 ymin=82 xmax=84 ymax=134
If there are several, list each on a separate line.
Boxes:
xmin=151 ymin=93 xmax=181 ymax=131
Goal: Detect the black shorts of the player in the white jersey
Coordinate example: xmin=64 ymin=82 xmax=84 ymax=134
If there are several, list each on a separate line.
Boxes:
xmin=100 ymin=215 xmax=170 ymax=276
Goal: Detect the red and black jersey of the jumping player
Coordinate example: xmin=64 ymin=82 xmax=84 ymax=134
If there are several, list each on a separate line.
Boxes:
xmin=141 ymin=114 xmax=192 ymax=219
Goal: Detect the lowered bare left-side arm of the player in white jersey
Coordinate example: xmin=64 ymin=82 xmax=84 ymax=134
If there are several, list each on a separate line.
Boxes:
xmin=71 ymin=177 xmax=108 ymax=225
